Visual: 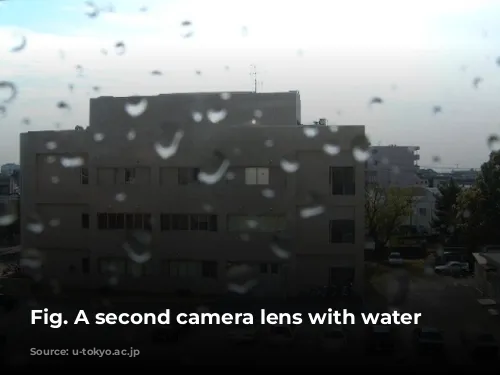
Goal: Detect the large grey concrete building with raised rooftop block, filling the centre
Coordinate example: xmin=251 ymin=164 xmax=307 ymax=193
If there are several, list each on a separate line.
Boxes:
xmin=21 ymin=92 xmax=364 ymax=295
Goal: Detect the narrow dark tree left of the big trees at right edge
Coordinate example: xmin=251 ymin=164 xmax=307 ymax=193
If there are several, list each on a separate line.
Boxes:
xmin=431 ymin=179 xmax=462 ymax=245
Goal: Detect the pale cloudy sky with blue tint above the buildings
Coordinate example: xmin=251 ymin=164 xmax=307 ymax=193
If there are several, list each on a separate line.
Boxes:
xmin=0 ymin=0 xmax=500 ymax=168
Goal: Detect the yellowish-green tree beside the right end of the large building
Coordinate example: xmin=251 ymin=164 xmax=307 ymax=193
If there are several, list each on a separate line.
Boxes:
xmin=365 ymin=184 xmax=414 ymax=256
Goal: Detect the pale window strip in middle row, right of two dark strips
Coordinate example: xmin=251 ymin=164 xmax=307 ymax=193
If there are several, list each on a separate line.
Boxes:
xmin=227 ymin=215 xmax=287 ymax=233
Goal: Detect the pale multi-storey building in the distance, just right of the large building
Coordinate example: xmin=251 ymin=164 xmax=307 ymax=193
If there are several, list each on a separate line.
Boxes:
xmin=366 ymin=145 xmax=425 ymax=187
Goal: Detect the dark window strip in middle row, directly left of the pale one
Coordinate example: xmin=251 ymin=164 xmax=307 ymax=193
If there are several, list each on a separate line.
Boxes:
xmin=160 ymin=214 xmax=218 ymax=232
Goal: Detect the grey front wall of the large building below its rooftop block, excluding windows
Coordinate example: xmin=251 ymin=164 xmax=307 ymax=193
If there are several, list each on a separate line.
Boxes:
xmin=21 ymin=92 xmax=364 ymax=294
